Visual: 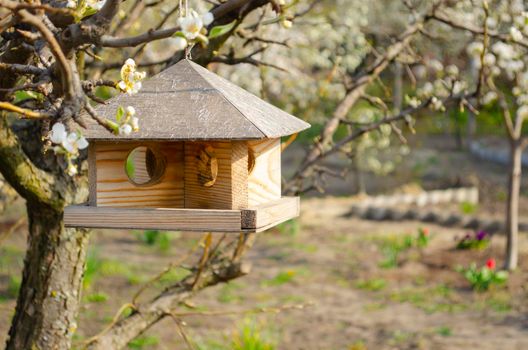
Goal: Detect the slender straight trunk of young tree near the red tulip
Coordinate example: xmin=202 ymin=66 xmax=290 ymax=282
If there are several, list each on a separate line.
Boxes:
xmin=504 ymin=141 xmax=522 ymax=270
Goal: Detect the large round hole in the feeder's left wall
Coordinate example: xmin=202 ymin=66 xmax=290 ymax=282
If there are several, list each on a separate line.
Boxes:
xmin=125 ymin=146 xmax=166 ymax=186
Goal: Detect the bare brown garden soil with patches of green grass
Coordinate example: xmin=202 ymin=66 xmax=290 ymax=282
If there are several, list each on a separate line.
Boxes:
xmin=0 ymin=136 xmax=528 ymax=350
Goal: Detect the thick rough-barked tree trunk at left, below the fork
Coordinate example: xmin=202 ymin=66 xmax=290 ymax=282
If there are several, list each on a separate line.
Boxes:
xmin=6 ymin=203 xmax=89 ymax=350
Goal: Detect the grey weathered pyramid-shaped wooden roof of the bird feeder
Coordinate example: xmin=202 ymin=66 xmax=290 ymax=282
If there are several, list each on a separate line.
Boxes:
xmin=84 ymin=59 xmax=310 ymax=140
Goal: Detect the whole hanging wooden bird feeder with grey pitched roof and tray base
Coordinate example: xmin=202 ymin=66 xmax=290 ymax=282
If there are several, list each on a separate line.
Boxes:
xmin=64 ymin=60 xmax=309 ymax=232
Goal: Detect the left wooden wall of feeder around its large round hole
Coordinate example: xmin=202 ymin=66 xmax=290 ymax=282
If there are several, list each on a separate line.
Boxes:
xmin=92 ymin=141 xmax=185 ymax=208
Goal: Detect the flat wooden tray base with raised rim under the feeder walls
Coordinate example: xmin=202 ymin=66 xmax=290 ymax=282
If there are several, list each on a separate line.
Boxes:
xmin=64 ymin=197 xmax=300 ymax=233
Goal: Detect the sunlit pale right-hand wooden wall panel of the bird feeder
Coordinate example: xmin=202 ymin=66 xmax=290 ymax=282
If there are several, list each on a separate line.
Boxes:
xmin=248 ymin=138 xmax=281 ymax=207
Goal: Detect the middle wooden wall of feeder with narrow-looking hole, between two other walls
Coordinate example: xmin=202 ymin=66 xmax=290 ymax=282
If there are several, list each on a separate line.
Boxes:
xmin=185 ymin=141 xmax=248 ymax=209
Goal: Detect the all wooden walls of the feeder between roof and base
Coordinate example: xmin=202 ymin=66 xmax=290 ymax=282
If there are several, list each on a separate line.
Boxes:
xmin=88 ymin=138 xmax=281 ymax=209
